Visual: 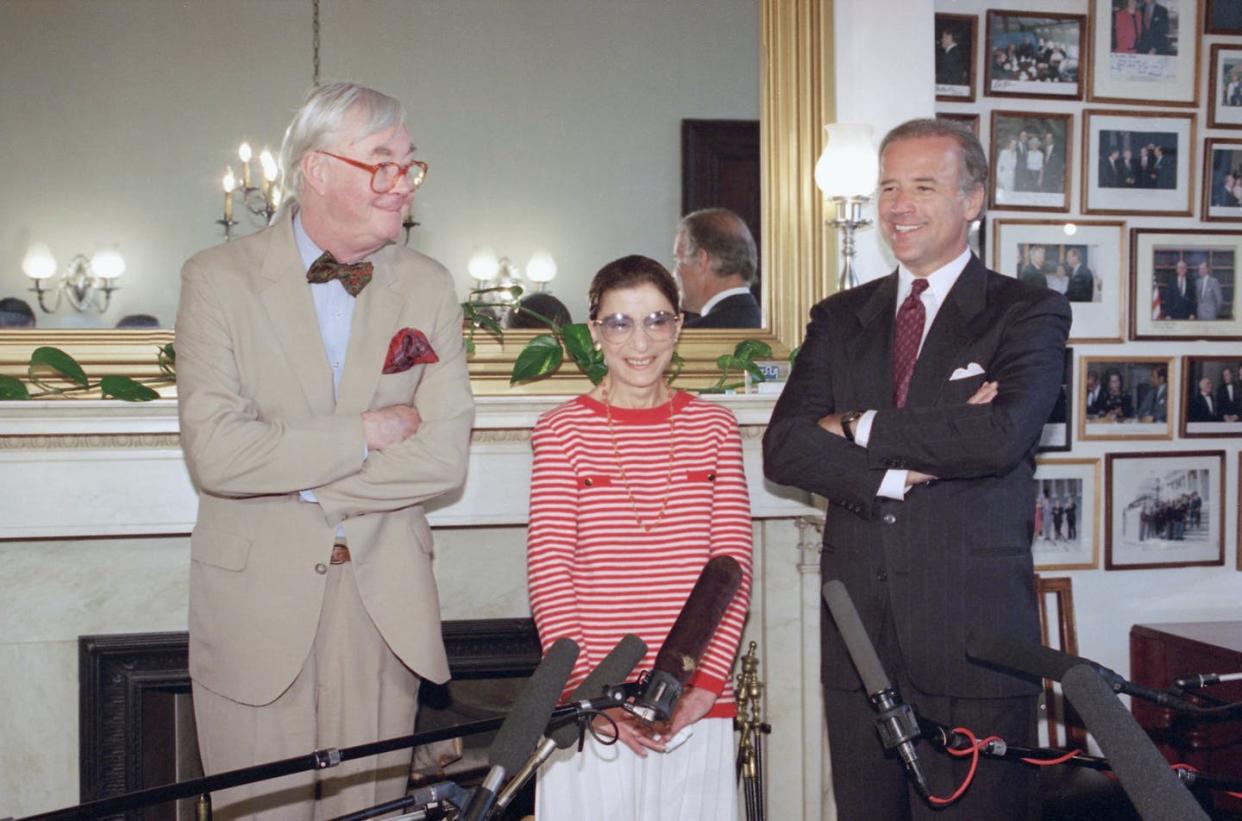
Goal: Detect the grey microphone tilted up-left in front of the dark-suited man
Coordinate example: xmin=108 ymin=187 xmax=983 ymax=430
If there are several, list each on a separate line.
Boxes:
xmin=823 ymin=579 xmax=932 ymax=799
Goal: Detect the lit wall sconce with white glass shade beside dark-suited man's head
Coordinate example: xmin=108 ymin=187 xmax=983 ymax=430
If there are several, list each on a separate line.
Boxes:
xmin=815 ymin=123 xmax=879 ymax=291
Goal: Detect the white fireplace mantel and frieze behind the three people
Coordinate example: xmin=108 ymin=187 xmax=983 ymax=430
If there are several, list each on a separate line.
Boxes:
xmin=0 ymin=396 xmax=816 ymax=539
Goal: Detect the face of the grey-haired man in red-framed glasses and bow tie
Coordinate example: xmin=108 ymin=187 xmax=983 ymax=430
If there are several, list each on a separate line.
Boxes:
xmin=301 ymin=105 xmax=414 ymax=262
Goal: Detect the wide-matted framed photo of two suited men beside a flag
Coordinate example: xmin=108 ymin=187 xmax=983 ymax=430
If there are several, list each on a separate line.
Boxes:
xmin=1130 ymin=229 xmax=1242 ymax=339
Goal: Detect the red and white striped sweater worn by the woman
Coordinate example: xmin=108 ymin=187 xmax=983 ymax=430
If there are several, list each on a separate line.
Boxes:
xmin=527 ymin=392 xmax=751 ymax=717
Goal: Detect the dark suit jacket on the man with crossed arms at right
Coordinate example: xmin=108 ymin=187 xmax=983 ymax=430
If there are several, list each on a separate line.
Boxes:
xmin=764 ymin=257 xmax=1071 ymax=697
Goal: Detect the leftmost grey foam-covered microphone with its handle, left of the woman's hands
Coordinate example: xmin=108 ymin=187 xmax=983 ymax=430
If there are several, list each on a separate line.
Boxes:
xmin=462 ymin=638 xmax=578 ymax=821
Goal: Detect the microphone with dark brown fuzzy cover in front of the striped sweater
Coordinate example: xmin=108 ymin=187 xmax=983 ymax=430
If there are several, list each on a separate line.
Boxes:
xmin=626 ymin=556 xmax=741 ymax=723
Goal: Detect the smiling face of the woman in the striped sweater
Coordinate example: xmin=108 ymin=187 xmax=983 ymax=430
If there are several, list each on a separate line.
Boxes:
xmin=590 ymin=283 xmax=682 ymax=406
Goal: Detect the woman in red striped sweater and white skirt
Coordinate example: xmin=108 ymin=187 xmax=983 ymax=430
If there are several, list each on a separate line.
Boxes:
xmin=527 ymin=256 xmax=751 ymax=821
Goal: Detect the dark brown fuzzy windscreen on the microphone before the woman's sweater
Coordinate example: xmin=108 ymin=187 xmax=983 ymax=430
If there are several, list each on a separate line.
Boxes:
xmin=653 ymin=556 xmax=741 ymax=684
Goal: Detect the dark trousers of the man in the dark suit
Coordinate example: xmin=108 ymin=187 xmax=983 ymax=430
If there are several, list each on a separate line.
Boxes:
xmin=823 ymin=598 xmax=1040 ymax=821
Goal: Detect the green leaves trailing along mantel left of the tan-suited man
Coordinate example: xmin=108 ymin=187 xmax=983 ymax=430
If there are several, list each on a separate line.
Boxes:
xmin=0 ymin=343 xmax=176 ymax=402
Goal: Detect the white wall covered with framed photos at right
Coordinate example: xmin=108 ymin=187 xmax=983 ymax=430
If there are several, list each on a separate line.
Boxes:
xmin=923 ymin=0 xmax=1242 ymax=669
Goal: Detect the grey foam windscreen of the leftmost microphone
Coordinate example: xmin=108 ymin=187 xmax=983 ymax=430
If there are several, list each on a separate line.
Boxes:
xmin=487 ymin=638 xmax=578 ymax=774
